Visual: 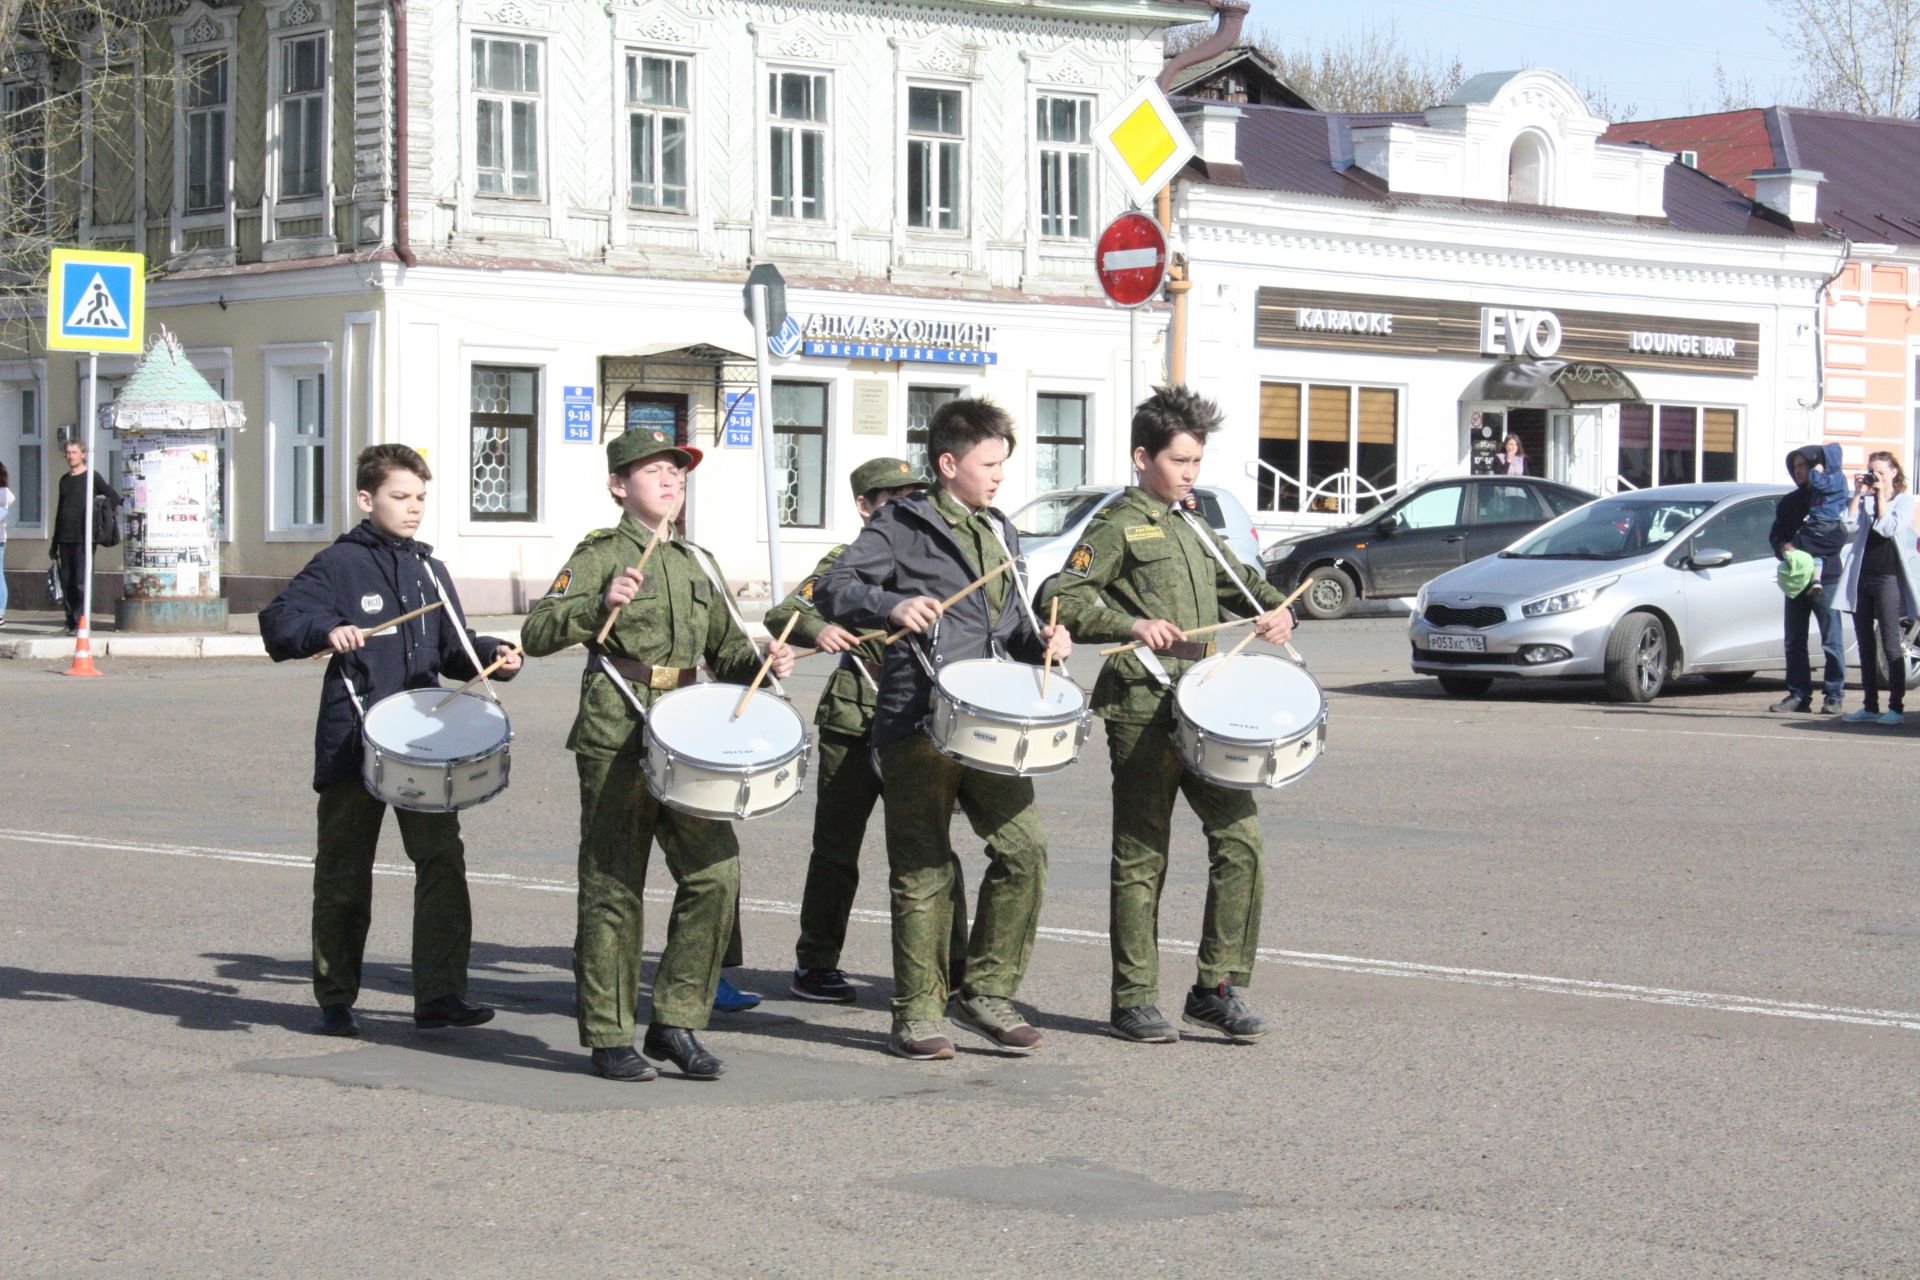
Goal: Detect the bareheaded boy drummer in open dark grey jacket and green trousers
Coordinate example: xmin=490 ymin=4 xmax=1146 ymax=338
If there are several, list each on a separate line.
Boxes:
xmin=814 ymin=399 xmax=1073 ymax=1059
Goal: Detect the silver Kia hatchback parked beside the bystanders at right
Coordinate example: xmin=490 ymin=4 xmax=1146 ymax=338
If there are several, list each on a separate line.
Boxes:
xmin=1409 ymin=484 xmax=1818 ymax=702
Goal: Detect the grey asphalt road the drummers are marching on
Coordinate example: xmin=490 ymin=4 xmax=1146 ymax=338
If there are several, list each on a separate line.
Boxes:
xmin=0 ymin=620 xmax=1920 ymax=1278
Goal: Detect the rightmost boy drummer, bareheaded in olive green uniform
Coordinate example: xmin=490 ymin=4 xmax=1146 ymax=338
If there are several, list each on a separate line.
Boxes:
xmin=1046 ymin=386 xmax=1294 ymax=1044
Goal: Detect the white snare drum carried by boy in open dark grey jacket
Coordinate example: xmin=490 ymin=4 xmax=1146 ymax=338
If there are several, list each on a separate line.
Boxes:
xmin=927 ymin=658 xmax=1092 ymax=777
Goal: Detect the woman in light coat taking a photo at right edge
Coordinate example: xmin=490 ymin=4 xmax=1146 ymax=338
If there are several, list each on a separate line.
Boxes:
xmin=1839 ymin=451 xmax=1920 ymax=725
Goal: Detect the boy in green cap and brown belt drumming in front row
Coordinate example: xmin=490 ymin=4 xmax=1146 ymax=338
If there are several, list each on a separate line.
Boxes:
xmin=520 ymin=430 xmax=793 ymax=1080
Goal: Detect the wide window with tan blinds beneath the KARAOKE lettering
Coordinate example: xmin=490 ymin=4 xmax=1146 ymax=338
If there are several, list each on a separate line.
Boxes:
xmin=1256 ymin=382 xmax=1400 ymax=514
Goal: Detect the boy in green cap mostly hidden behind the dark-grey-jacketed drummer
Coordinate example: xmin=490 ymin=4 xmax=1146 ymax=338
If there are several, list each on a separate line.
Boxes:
xmin=764 ymin=459 xmax=966 ymax=1004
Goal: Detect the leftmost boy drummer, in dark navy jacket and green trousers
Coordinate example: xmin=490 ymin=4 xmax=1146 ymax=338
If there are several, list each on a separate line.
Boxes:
xmin=259 ymin=445 xmax=520 ymax=1036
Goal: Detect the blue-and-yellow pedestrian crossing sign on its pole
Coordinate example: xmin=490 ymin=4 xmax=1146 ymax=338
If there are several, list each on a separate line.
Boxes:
xmin=46 ymin=249 xmax=146 ymax=676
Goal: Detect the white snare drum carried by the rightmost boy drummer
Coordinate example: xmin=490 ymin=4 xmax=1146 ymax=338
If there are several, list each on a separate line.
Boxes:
xmin=1173 ymin=652 xmax=1327 ymax=791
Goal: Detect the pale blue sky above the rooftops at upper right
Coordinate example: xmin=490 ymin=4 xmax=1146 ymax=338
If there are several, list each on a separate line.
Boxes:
xmin=1250 ymin=0 xmax=1797 ymax=119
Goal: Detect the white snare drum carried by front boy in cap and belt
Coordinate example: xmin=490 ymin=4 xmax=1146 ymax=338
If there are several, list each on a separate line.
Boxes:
xmin=647 ymin=685 xmax=808 ymax=819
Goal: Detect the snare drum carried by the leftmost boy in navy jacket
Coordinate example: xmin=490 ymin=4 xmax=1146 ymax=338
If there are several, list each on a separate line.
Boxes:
xmin=361 ymin=689 xmax=513 ymax=814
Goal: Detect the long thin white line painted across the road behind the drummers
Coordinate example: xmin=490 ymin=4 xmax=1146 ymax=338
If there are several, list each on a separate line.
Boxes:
xmin=0 ymin=827 xmax=1920 ymax=1031
